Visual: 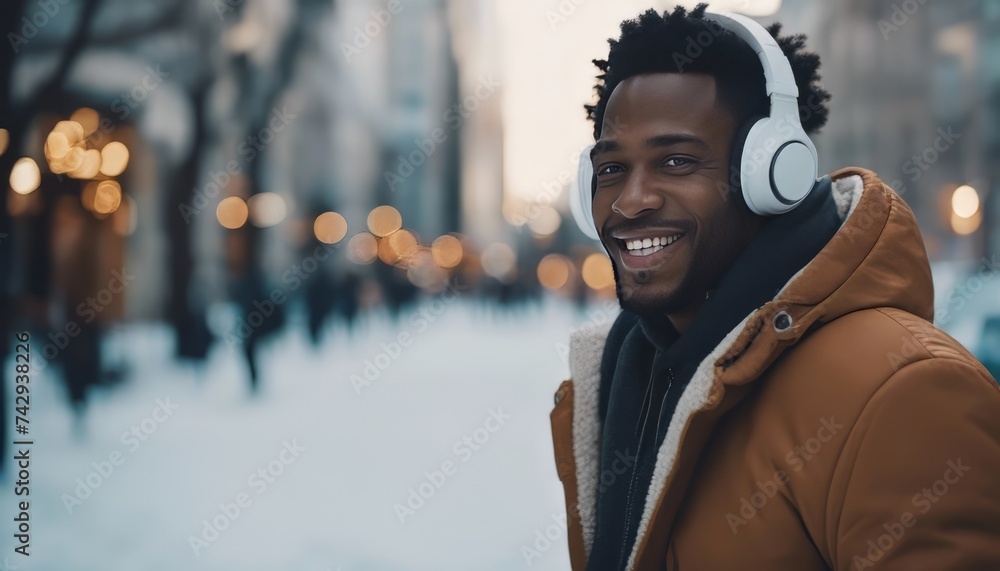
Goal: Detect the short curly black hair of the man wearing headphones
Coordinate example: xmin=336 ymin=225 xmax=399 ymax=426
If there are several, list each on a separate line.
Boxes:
xmin=584 ymin=3 xmax=830 ymax=140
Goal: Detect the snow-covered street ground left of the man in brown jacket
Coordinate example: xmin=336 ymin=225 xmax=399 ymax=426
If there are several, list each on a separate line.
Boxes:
xmin=0 ymin=300 xmax=614 ymax=571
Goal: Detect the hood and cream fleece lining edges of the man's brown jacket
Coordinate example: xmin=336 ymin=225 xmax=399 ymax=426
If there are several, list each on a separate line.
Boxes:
xmin=569 ymin=168 xmax=934 ymax=569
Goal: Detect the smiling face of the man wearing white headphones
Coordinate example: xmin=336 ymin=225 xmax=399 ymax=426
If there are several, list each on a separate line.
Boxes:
xmin=592 ymin=73 xmax=763 ymax=325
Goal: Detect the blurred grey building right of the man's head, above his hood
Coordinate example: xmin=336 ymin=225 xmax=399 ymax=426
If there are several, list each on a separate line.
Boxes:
xmin=764 ymin=0 xmax=1000 ymax=260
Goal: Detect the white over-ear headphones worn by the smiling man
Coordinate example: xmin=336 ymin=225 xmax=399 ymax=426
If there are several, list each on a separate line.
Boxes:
xmin=570 ymin=12 xmax=819 ymax=240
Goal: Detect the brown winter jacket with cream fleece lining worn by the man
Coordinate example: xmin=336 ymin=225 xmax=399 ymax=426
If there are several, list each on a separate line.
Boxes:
xmin=551 ymin=169 xmax=1000 ymax=571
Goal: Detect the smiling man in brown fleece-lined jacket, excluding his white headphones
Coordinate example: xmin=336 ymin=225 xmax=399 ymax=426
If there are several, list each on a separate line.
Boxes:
xmin=552 ymin=5 xmax=1000 ymax=571
